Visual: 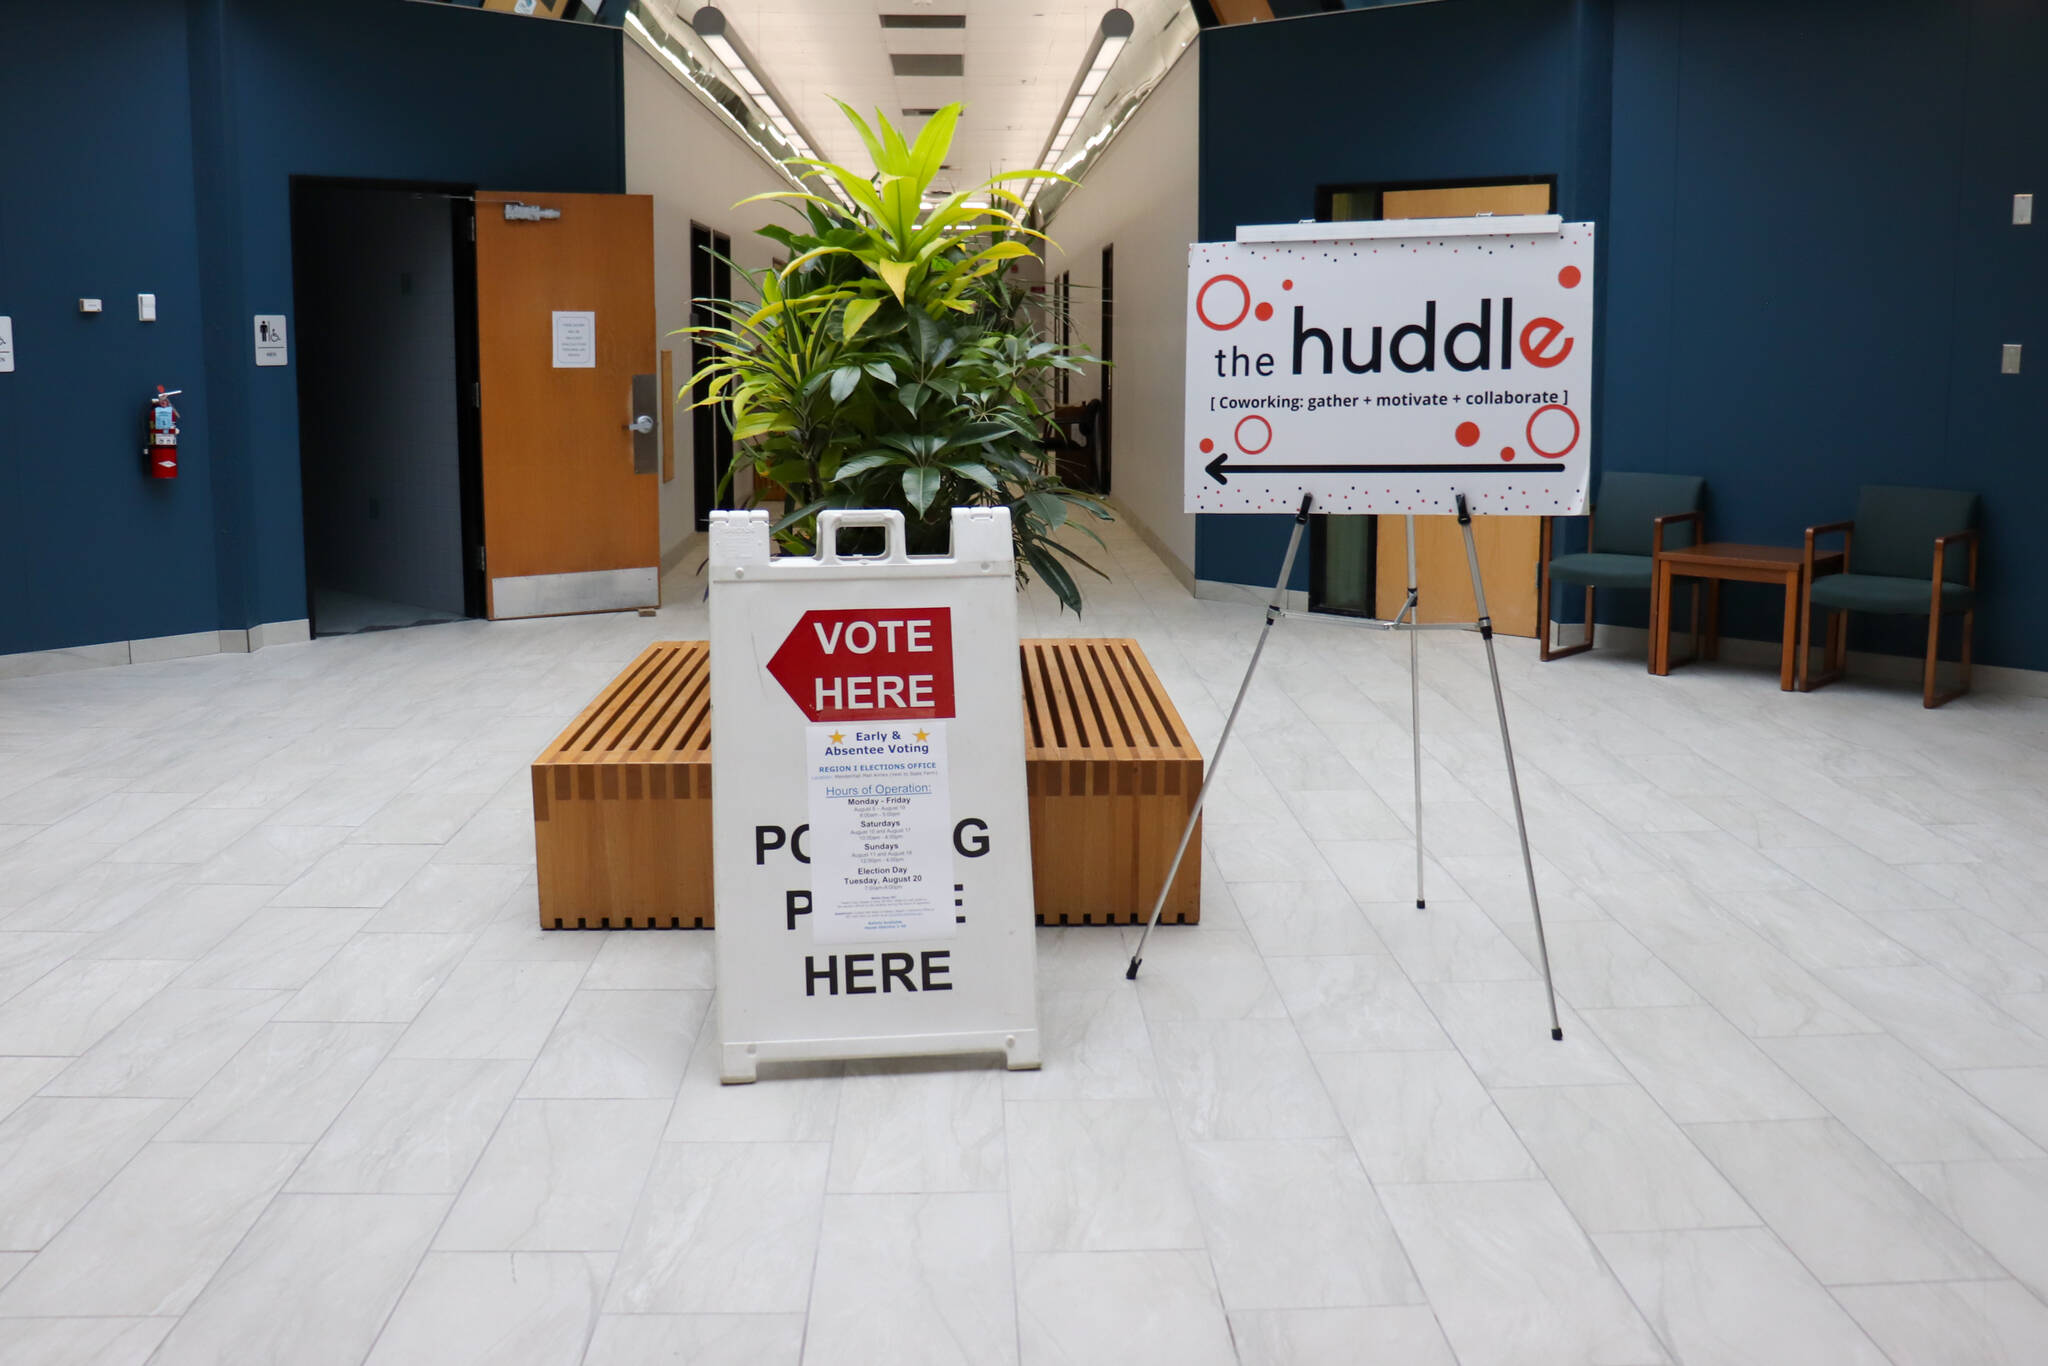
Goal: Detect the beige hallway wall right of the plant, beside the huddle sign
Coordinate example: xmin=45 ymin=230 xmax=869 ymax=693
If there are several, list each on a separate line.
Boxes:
xmin=1047 ymin=45 xmax=1200 ymax=584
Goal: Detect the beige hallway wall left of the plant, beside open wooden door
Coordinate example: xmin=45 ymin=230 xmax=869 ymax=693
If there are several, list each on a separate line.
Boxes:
xmin=625 ymin=41 xmax=788 ymax=555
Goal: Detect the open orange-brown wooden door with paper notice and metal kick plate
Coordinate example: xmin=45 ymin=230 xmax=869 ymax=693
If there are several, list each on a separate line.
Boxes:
xmin=477 ymin=190 xmax=662 ymax=618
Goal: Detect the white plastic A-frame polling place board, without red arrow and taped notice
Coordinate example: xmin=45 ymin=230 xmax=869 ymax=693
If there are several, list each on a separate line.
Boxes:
xmin=711 ymin=508 xmax=1040 ymax=1083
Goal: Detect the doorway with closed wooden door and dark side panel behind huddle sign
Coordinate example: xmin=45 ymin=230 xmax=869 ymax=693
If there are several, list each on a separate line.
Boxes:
xmin=1309 ymin=176 xmax=1556 ymax=635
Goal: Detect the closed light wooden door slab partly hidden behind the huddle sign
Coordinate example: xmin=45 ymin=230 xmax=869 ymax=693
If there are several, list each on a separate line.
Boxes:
xmin=1372 ymin=184 xmax=1550 ymax=637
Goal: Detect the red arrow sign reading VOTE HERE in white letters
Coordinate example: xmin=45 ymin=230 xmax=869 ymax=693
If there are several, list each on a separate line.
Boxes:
xmin=768 ymin=606 xmax=952 ymax=721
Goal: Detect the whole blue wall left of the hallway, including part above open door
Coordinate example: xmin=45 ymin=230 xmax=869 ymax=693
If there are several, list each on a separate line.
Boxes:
xmin=0 ymin=0 xmax=625 ymax=653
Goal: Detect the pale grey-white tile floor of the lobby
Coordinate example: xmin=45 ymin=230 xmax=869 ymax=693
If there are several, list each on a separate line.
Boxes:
xmin=0 ymin=516 xmax=2048 ymax=1366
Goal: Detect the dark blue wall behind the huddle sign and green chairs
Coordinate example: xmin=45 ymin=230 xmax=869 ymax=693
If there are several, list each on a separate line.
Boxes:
xmin=1196 ymin=0 xmax=2048 ymax=668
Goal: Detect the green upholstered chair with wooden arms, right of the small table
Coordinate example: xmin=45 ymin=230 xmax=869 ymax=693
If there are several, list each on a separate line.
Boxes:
xmin=1798 ymin=483 xmax=1976 ymax=707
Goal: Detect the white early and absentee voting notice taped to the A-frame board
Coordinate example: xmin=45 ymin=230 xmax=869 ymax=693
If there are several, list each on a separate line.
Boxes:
xmin=805 ymin=721 xmax=956 ymax=944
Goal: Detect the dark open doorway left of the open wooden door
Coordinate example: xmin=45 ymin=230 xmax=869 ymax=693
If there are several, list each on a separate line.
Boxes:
xmin=291 ymin=176 xmax=483 ymax=635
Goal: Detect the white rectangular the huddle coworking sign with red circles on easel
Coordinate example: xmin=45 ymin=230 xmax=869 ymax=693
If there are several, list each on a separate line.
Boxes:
xmin=1182 ymin=217 xmax=1593 ymax=514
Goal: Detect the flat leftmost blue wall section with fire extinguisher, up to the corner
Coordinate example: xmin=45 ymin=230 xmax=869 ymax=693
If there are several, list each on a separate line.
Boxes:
xmin=0 ymin=4 xmax=221 ymax=653
